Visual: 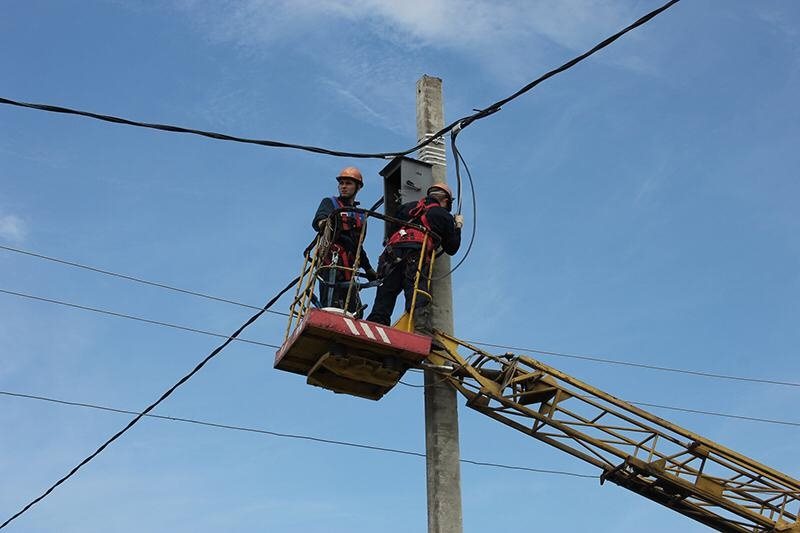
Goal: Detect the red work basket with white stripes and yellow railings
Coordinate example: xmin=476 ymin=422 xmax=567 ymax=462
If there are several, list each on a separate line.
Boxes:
xmin=274 ymin=204 xmax=434 ymax=400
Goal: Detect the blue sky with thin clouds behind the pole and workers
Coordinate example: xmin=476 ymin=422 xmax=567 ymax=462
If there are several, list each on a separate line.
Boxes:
xmin=0 ymin=0 xmax=800 ymax=533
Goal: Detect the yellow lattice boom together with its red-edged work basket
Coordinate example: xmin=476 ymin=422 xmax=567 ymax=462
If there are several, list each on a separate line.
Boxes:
xmin=275 ymin=203 xmax=800 ymax=533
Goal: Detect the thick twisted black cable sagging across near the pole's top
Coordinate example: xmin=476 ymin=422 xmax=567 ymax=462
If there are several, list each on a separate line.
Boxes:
xmin=0 ymin=0 xmax=680 ymax=159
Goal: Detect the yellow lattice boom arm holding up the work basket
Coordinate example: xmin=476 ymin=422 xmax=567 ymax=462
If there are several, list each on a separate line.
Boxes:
xmin=429 ymin=333 xmax=800 ymax=533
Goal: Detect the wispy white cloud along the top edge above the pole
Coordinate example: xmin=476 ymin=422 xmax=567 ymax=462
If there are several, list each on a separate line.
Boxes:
xmin=174 ymin=0 xmax=641 ymax=56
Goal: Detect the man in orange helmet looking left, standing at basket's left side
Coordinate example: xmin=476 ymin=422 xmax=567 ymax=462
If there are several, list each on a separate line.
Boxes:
xmin=311 ymin=167 xmax=378 ymax=314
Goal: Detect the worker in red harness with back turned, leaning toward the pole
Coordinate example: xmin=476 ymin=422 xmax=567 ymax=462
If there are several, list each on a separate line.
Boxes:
xmin=367 ymin=183 xmax=464 ymax=335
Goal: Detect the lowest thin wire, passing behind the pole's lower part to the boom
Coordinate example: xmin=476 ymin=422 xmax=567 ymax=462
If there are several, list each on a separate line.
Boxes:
xmin=0 ymin=391 xmax=598 ymax=479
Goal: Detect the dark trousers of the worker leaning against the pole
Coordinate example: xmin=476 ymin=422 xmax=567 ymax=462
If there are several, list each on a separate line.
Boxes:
xmin=367 ymin=246 xmax=431 ymax=331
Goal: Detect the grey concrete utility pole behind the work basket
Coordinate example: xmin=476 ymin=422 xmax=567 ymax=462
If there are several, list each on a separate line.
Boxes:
xmin=417 ymin=76 xmax=462 ymax=533
